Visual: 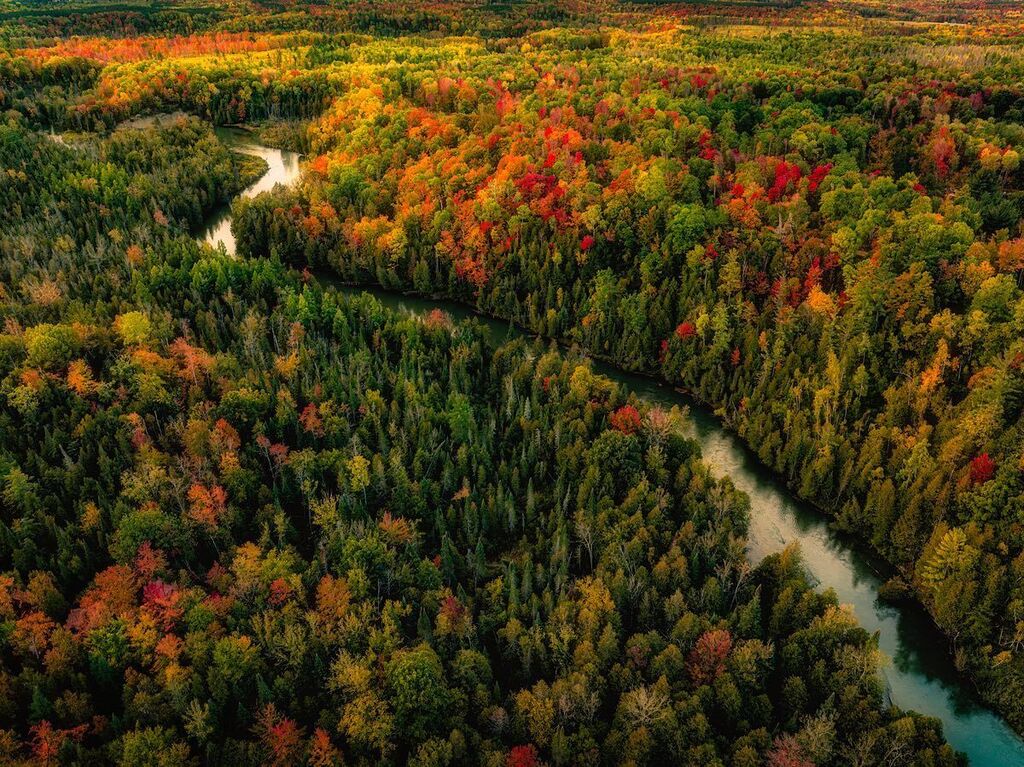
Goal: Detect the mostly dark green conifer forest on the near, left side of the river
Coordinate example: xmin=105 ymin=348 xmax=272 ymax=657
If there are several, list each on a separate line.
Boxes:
xmin=0 ymin=100 xmax=958 ymax=767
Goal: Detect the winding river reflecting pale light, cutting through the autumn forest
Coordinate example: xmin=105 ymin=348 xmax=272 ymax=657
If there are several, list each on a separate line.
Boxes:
xmin=201 ymin=129 xmax=1024 ymax=767
